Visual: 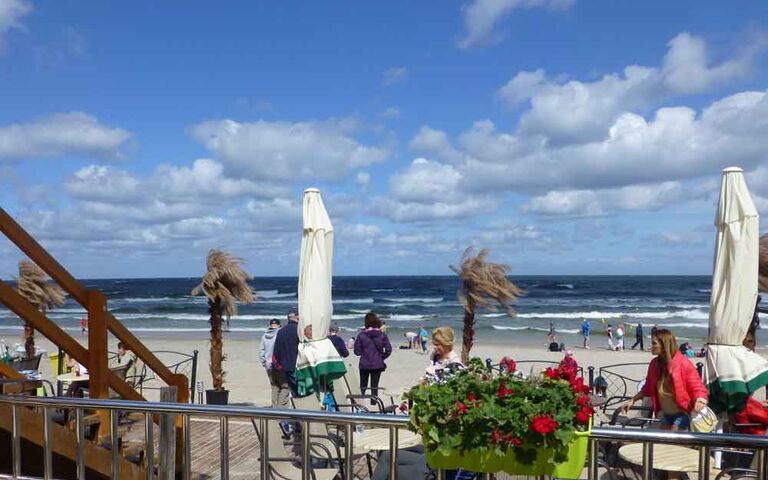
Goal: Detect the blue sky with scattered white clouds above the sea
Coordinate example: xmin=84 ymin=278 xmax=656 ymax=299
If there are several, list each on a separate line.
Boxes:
xmin=0 ymin=0 xmax=768 ymax=279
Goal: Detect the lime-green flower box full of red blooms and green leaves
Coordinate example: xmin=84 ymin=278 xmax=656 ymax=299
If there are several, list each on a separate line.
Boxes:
xmin=406 ymin=357 xmax=593 ymax=478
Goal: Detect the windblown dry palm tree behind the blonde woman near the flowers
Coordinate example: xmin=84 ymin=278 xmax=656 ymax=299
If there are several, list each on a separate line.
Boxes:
xmin=451 ymin=247 xmax=525 ymax=365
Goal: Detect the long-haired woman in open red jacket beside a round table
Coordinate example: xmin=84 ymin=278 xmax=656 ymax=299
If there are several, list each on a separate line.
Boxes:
xmin=622 ymin=329 xmax=708 ymax=430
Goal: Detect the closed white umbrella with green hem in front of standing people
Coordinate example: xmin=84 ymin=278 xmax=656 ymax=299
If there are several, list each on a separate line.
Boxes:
xmin=296 ymin=188 xmax=347 ymax=397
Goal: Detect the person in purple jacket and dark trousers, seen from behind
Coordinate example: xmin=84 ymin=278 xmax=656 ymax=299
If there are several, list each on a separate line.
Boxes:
xmin=354 ymin=312 xmax=392 ymax=397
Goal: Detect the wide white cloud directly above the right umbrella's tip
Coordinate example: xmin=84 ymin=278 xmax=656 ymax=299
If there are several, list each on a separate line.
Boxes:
xmin=460 ymin=92 xmax=768 ymax=191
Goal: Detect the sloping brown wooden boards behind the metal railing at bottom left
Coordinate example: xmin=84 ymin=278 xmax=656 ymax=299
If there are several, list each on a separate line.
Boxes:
xmin=0 ymin=405 xmax=146 ymax=480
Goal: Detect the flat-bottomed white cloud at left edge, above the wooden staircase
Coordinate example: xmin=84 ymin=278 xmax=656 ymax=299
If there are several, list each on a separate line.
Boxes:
xmin=0 ymin=112 xmax=131 ymax=161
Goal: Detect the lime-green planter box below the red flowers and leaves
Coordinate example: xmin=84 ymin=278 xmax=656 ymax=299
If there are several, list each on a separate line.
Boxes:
xmin=426 ymin=432 xmax=589 ymax=478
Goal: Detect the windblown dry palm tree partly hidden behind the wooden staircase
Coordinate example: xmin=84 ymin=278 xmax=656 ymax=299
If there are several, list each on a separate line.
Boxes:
xmin=16 ymin=260 xmax=67 ymax=357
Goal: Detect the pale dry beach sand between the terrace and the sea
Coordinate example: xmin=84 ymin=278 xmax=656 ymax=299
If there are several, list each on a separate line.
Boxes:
xmin=24 ymin=334 xmax=766 ymax=406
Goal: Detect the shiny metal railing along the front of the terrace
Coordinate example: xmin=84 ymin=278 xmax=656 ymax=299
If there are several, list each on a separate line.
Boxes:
xmin=0 ymin=395 xmax=768 ymax=480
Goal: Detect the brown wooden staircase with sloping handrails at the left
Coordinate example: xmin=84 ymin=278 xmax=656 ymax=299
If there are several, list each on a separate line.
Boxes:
xmin=0 ymin=208 xmax=189 ymax=479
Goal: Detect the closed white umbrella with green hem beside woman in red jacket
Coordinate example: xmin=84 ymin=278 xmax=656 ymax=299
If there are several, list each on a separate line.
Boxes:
xmin=705 ymin=167 xmax=768 ymax=412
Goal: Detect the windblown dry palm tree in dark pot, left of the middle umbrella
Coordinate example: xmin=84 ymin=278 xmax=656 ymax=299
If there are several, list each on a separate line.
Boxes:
xmin=192 ymin=250 xmax=256 ymax=391
